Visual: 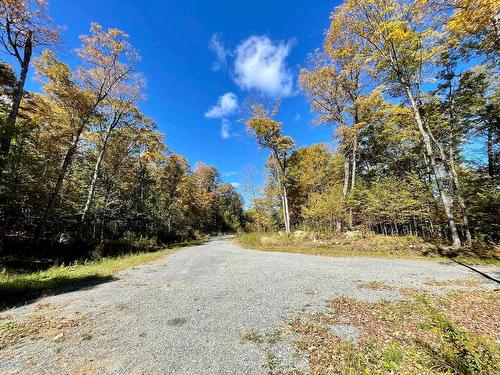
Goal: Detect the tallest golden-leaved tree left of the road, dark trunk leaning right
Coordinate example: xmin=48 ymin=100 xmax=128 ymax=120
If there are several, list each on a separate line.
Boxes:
xmin=37 ymin=23 xmax=138 ymax=241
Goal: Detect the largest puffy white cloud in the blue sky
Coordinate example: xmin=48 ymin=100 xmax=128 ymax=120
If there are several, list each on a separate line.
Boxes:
xmin=234 ymin=35 xmax=292 ymax=96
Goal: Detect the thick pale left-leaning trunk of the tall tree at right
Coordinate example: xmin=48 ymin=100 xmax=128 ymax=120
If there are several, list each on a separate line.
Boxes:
xmin=403 ymin=83 xmax=462 ymax=249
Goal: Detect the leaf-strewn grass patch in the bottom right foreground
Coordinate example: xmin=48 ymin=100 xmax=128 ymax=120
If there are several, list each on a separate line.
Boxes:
xmin=290 ymin=291 xmax=500 ymax=375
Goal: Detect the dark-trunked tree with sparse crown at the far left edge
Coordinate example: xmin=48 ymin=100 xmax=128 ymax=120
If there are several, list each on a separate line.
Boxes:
xmin=0 ymin=0 xmax=59 ymax=173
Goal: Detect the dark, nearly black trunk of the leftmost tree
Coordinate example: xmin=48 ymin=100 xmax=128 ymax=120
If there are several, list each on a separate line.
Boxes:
xmin=0 ymin=32 xmax=33 ymax=177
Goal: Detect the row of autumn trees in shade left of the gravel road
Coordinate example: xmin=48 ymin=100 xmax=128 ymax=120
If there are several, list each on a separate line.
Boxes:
xmin=0 ymin=0 xmax=243 ymax=256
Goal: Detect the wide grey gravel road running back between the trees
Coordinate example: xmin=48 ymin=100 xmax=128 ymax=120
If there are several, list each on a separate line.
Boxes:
xmin=0 ymin=237 xmax=500 ymax=375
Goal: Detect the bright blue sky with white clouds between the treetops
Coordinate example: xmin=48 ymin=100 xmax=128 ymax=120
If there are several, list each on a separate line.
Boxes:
xmin=20 ymin=0 xmax=337 ymax=203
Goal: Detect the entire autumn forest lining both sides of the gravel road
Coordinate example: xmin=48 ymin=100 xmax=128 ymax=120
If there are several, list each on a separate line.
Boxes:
xmin=0 ymin=0 xmax=500 ymax=270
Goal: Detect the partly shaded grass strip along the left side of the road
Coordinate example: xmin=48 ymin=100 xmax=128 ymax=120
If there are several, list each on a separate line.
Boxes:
xmin=0 ymin=242 xmax=203 ymax=309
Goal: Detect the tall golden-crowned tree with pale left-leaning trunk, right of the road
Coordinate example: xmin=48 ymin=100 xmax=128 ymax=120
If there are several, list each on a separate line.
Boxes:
xmin=330 ymin=0 xmax=461 ymax=248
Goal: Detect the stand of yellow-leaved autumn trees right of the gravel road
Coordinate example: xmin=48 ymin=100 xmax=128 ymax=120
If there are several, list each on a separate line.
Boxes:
xmin=247 ymin=0 xmax=500 ymax=248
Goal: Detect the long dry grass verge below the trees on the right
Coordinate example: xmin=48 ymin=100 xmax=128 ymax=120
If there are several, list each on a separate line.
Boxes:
xmin=236 ymin=233 xmax=500 ymax=266
